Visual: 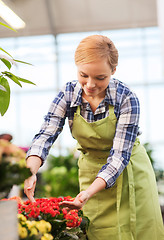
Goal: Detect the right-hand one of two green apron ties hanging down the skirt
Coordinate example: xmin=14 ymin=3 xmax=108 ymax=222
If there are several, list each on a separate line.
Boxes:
xmin=127 ymin=161 xmax=136 ymax=239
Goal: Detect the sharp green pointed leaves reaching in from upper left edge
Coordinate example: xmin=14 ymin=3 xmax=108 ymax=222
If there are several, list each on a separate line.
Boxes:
xmin=0 ymin=22 xmax=35 ymax=116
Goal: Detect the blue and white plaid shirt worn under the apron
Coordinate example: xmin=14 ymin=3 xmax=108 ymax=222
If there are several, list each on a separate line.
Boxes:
xmin=27 ymin=78 xmax=140 ymax=188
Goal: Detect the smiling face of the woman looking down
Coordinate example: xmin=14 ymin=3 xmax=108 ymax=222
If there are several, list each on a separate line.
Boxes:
xmin=77 ymin=60 xmax=115 ymax=98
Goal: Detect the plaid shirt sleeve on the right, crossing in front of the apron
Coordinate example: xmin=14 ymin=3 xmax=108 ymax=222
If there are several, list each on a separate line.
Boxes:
xmin=97 ymin=92 xmax=140 ymax=188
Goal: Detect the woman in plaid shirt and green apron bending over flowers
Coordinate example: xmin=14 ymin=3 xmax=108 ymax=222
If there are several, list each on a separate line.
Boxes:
xmin=25 ymin=35 xmax=164 ymax=240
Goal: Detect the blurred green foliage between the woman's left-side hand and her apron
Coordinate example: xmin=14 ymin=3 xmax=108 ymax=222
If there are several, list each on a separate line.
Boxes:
xmin=35 ymin=154 xmax=79 ymax=197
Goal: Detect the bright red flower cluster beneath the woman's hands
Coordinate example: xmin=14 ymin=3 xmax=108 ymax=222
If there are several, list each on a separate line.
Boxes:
xmin=18 ymin=197 xmax=82 ymax=228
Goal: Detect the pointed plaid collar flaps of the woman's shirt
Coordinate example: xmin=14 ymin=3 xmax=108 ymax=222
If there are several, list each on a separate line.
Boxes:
xmin=70 ymin=78 xmax=116 ymax=107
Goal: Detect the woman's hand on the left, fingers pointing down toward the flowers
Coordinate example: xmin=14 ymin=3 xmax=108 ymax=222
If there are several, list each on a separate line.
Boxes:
xmin=24 ymin=174 xmax=37 ymax=202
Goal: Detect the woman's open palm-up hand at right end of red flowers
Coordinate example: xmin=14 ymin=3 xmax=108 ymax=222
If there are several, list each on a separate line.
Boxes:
xmin=60 ymin=191 xmax=89 ymax=210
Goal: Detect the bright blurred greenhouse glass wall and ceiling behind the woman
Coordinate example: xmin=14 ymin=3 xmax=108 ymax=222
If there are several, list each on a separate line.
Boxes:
xmin=0 ymin=0 xmax=164 ymax=203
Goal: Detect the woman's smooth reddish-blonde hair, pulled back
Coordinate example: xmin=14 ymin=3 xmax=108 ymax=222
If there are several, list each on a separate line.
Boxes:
xmin=75 ymin=35 xmax=118 ymax=71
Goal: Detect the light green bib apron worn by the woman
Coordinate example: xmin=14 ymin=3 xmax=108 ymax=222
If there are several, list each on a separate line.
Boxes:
xmin=72 ymin=106 xmax=164 ymax=240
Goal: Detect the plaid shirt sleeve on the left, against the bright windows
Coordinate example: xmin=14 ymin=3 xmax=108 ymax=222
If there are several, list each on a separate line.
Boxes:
xmin=26 ymin=91 xmax=66 ymax=163
